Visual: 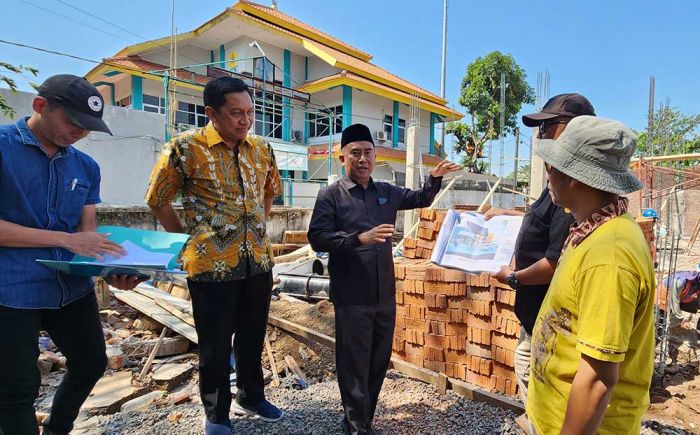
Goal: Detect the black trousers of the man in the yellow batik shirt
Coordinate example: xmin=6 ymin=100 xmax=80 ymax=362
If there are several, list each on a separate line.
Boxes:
xmin=187 ymin=272 xmax=272 ymax=423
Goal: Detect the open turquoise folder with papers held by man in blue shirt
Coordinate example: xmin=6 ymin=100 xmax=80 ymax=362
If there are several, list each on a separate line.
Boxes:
xmin=37 ymin=226 xmax=189 ymax=281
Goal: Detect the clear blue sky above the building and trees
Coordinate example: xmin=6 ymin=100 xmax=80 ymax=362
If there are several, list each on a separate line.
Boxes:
xmin=0 ymin=0 xmax=700 ymax=175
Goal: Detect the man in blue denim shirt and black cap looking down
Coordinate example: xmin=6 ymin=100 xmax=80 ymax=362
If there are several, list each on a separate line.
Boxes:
xmin=0 ymin=75 xmax=138 ymax=435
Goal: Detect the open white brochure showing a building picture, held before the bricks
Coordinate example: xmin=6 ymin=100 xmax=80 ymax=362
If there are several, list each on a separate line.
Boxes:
xmin=430 ymin=210 xmax=523 ymax=273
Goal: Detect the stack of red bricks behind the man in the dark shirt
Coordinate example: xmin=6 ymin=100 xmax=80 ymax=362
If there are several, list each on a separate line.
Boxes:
xmin=393 ymin=210 xmax=520 ymax=395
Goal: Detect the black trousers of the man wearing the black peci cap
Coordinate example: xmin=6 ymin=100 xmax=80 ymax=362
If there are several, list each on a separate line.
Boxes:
xmin=335 ymin=301 xmax=396 ymax=434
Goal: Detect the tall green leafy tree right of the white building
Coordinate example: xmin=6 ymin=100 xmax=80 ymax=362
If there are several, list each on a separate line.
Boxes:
xmin=446 ymin=51 xmax=535 ymax=173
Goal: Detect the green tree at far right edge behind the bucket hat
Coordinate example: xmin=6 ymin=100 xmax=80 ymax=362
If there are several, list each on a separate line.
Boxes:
xmin=637 ymin=107 xmax=700 ymax=165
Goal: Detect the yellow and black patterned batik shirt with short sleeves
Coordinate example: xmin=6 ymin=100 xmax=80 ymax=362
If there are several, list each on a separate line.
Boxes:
xmin=146 ymin=122 xmax=282 ymax=282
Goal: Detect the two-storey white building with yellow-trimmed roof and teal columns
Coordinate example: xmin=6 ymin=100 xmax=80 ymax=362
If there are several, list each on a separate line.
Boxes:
xmin=86 ymin=0 xmax=462 ymax=184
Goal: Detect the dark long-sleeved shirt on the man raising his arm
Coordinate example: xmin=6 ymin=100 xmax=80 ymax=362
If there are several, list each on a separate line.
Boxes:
xmin=309 ymin=176 xmax=442 ymax=305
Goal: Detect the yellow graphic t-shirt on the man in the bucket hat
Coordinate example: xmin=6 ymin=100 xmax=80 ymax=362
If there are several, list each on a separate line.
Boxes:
xmin=526 ymin=213 xmax=655 ymax=435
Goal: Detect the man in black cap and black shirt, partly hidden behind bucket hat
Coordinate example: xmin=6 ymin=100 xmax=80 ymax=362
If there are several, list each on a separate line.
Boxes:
xmin=485 ymin=94 xmax=595 ymax=408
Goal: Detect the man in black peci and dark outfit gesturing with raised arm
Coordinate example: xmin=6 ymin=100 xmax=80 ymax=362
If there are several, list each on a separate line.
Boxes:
xmin=309 ymin=124 xmax=461 ymax=434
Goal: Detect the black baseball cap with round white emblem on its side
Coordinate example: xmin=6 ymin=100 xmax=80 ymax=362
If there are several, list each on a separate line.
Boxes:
xmin=38 ymin=74 xmax=112 ymax=134
